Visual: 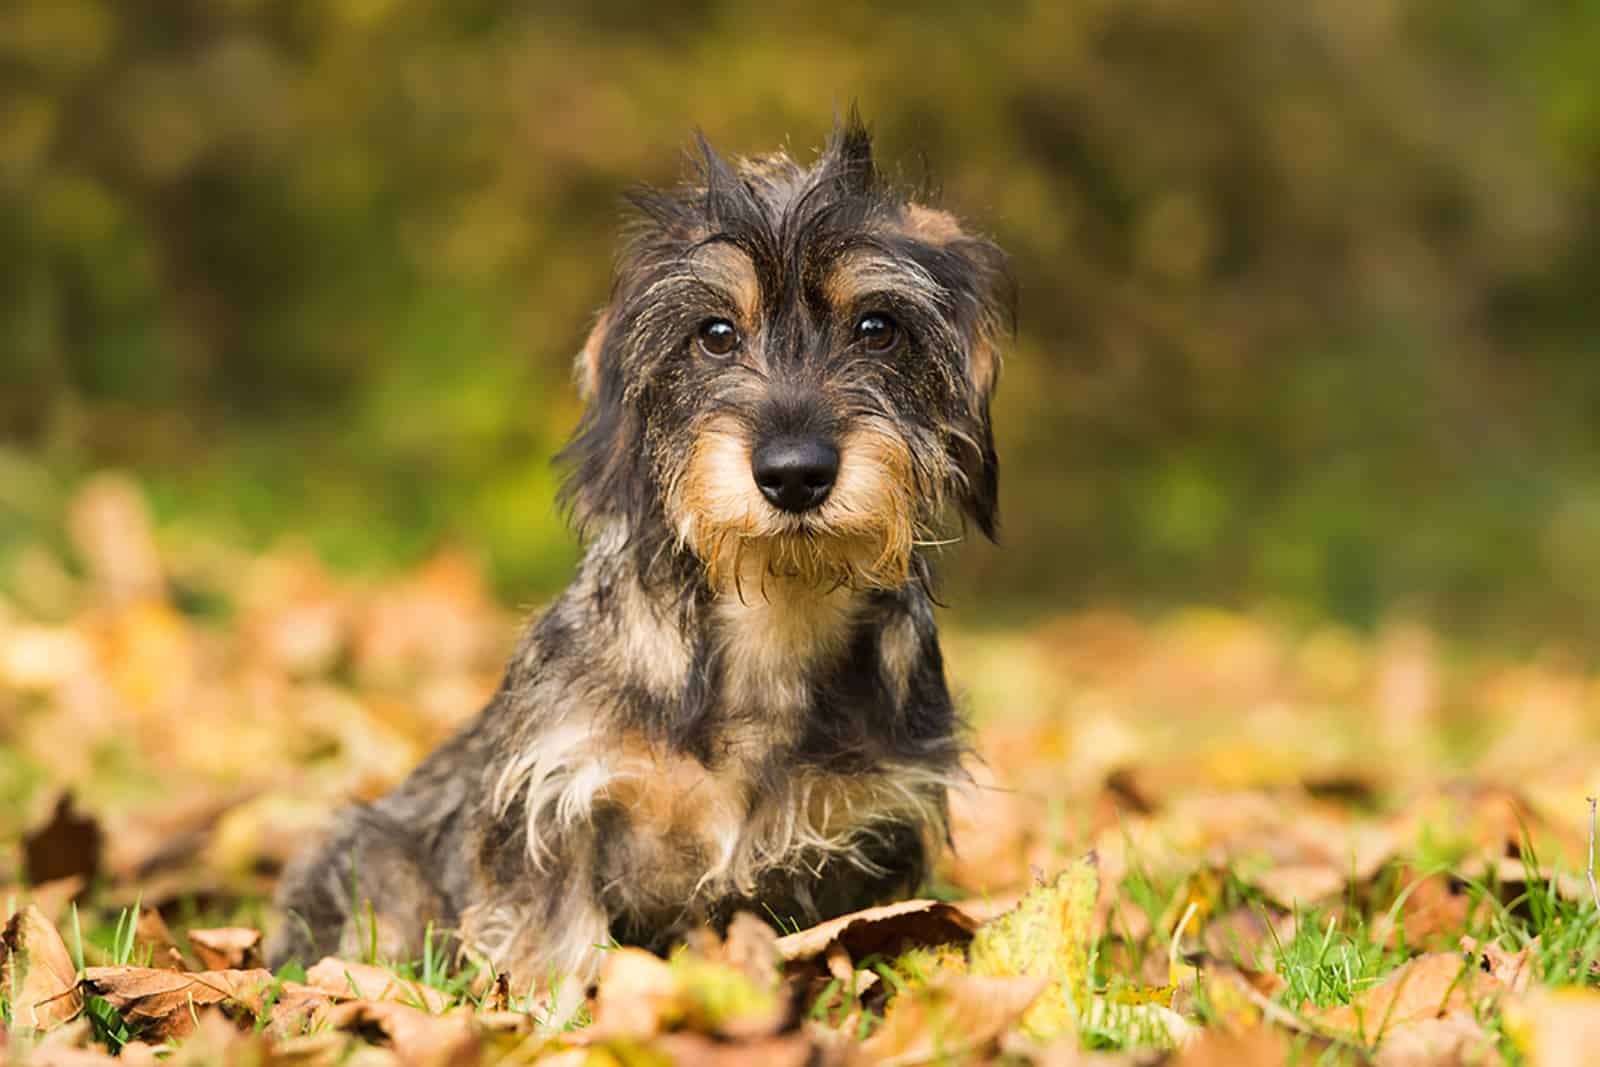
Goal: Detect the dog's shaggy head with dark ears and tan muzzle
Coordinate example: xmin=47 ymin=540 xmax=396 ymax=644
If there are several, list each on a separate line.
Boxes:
xmin=566 ymin=122 xmax=1010 ymax=595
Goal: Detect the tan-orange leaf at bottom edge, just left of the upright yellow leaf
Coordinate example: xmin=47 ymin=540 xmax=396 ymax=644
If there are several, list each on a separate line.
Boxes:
xmin=861 ymin=974 xmax=1050 ymax=1067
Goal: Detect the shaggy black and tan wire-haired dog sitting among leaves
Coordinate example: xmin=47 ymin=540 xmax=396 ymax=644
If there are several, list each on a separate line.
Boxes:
xmin=269 ymin=112 xmax=1013 ymax=984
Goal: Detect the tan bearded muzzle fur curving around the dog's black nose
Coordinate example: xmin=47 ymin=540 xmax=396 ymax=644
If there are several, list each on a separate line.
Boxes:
xmin=669 ymin=419 xmax=918 ymax=598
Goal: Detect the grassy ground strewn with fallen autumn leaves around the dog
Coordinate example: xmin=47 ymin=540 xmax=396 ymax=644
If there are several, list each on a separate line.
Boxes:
xmin=0 ymin=477 xmax=1600 ymax=1067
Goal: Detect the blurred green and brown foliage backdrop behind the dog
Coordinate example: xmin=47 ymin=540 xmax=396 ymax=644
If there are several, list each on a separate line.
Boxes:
xmin=0 ymin=0 xmax=1600 ymax=635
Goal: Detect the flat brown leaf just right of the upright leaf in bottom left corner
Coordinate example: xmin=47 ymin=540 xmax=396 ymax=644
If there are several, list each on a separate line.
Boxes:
xmin=83 ymin=966 xmax=272 ymax=1040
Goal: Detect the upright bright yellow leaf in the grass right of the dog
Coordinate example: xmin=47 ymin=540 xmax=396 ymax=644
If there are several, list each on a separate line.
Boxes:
xmin=970 ymin=853 xmax=1099 ymax=1041
